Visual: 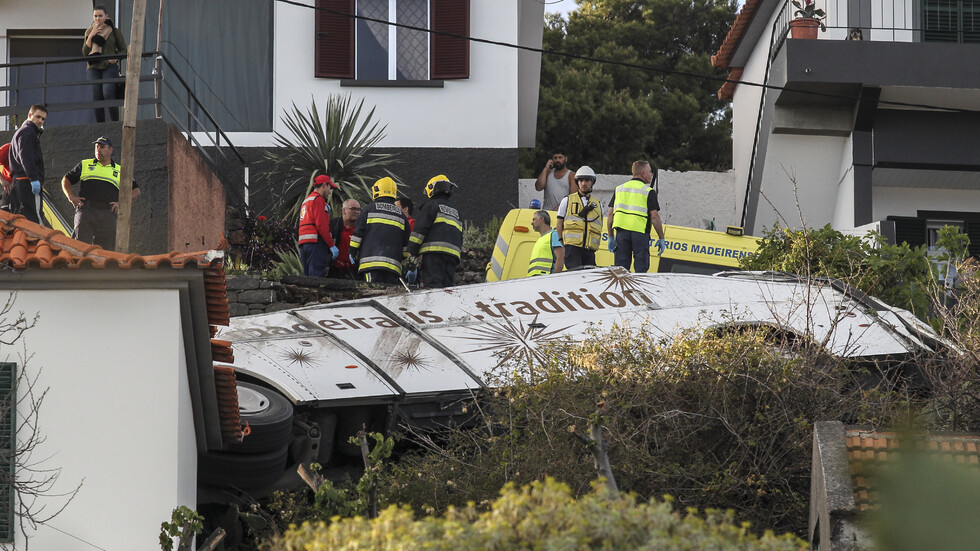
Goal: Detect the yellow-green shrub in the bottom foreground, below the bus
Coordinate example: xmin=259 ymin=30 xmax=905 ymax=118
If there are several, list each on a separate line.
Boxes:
xmin=266 ymin=479 xmax=806 ymax=551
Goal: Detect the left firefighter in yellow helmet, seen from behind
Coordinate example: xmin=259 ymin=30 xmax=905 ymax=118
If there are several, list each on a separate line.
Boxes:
xmin=350 ymin=177 xmax=411 ymax=283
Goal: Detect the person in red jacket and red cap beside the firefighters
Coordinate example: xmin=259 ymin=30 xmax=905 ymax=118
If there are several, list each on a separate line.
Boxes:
xmin=299 ymin=174 xmax=340 ymax=277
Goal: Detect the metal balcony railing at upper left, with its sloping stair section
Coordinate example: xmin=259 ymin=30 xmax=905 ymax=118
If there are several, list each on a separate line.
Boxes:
xmin=0 ymin=52 xmax=249 ymax=207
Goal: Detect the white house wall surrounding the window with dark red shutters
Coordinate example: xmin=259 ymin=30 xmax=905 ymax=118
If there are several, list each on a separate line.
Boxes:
xmin=255 ymin=0 xmax=528 ymax=148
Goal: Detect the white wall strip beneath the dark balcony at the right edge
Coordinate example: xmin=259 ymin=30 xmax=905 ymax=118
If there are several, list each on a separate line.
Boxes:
xmin=871 ymin=186 xmax=980 ymax=220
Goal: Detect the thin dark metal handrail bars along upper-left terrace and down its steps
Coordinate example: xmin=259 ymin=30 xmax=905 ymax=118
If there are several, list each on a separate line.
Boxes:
xmin=0 ymin=52 xmax=249 ymax=207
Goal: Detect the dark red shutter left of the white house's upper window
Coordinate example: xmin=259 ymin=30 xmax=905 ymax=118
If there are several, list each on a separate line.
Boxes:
xmin=315 ymin=0 xmax=354 ymax=78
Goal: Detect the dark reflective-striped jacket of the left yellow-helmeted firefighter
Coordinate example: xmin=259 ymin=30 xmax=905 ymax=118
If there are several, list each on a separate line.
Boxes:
xmin=350 ymin=197 xmax=411 ymax=276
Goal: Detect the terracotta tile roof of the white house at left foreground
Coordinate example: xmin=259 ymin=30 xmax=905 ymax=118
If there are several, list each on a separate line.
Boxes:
xmin=0 ymin=210 xmax=243 ymax=443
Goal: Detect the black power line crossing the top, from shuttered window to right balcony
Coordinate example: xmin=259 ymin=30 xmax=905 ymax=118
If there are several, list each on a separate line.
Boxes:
xmin=275 ymin=0 xmax=980 ymax=113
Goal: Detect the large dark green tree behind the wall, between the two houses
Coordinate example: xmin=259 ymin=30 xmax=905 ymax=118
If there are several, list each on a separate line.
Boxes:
xmin=522 ymin=0 xmax=736 ymax=176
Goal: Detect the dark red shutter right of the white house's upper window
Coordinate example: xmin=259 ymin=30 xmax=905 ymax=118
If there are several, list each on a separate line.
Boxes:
xmin=429 ymin=0 xmax=470 ymax=80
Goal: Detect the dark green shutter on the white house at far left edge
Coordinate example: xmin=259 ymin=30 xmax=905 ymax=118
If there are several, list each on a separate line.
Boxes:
xmin=0 ymin=363 xmax=17 ymax=543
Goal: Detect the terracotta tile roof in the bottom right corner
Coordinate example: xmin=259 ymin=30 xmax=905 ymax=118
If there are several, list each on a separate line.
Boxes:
xmin=844 ymin=427 xmax=980 ymax=511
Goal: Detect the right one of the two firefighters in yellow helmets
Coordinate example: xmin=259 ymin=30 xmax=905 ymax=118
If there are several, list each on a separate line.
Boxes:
xmin=408 ymin=174 xmax=463 ymax=289
